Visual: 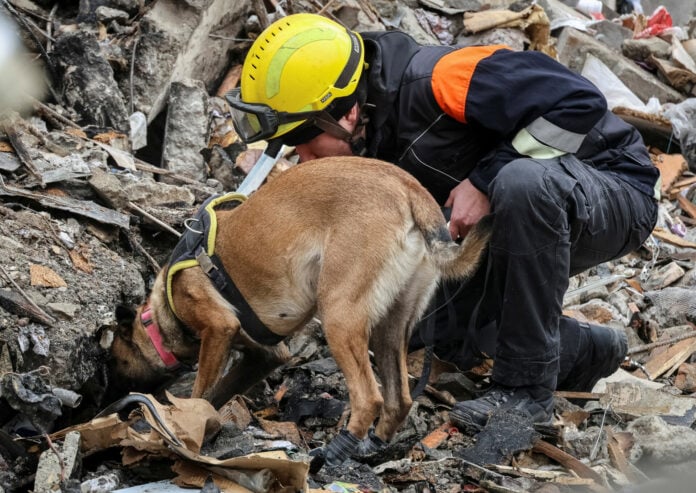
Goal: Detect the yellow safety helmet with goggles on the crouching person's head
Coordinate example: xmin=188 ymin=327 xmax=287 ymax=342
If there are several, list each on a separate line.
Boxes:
xmin=226 ymin=14 xmax=364 ymax=145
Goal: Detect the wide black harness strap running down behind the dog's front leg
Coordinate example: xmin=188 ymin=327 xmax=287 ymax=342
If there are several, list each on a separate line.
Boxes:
xmin=196 ymin=248 xmax=285 ymax=346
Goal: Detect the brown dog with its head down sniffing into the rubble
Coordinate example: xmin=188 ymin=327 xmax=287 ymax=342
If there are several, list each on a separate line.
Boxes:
xmin=111 ymin=157 xmax=490 ymax=463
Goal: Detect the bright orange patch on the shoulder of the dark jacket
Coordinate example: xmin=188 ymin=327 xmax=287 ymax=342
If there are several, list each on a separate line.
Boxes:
xmin=431 ymin=45 xmax=510 ymax=123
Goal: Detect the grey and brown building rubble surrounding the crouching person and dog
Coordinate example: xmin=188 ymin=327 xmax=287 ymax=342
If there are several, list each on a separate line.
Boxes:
xmin=0 ymin=0 xmax=696 ymax=493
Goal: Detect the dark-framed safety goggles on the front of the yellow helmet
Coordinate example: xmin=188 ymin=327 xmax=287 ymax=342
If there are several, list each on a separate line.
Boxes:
xmin=225 ymin=88 xmax=322 ymax=143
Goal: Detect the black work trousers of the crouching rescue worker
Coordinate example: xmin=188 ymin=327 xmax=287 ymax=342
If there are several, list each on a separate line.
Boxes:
xmin=411 ymin=155 xmax=657 ymax=388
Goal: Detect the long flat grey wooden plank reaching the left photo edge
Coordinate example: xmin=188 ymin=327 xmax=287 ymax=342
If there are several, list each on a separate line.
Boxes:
xmin=0 ymin=178 xmax=130 ymax=229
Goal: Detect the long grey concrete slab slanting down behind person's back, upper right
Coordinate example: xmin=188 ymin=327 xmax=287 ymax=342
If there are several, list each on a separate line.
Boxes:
xmin=556 ymin=27 xmax=685 ymax=104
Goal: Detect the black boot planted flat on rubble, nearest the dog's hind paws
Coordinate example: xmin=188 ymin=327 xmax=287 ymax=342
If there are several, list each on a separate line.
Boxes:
xmin=449 ymin=384 xmax=553 ymax=433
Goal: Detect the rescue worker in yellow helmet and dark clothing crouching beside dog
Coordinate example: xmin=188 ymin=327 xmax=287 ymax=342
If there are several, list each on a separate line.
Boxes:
xmin=228 ymin=14 xmax=659 ymax=438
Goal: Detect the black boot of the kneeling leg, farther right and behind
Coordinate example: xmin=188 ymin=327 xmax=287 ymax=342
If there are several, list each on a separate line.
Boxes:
xmin=558 ymin=317 xmax=628 ymax=392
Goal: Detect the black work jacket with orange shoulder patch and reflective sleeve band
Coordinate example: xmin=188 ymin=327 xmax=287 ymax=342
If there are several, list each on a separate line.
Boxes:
xmin=361 ymin=31 xmax=659 ymax=204
